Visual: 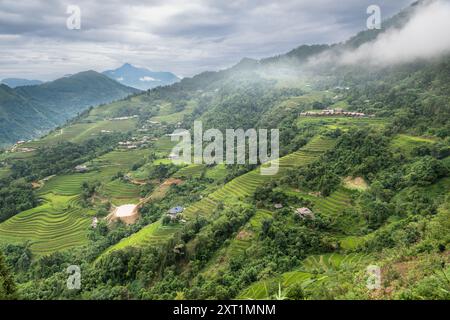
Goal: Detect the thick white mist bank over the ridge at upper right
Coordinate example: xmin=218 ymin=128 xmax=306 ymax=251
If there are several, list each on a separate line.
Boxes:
xmin=309 ymin=0 xmax=450 ymax=67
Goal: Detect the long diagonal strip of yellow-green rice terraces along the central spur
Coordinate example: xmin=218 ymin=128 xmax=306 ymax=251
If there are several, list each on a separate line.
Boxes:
xmin=100 ymin=137 xmax=333 ymax=256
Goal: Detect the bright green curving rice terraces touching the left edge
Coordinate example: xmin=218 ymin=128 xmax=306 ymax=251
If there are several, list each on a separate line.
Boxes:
xmin=0 ymin=194 xmax=92 ymax=256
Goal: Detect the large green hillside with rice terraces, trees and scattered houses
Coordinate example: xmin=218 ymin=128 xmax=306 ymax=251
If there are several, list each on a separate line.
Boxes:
xmin=0 ymin=0 xmax=450 ymax=300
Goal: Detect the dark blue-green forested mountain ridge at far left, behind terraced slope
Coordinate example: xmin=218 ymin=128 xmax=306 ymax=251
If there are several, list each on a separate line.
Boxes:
xmin=0 ymin=71 xmax=138 ymax=146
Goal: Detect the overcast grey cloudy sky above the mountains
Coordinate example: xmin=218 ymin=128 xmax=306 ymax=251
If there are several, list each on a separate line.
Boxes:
xmin=0 ymin=0 xmax=413 ymax=80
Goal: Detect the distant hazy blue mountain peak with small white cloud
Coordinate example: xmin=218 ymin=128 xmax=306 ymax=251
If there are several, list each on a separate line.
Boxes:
xmin=103 ymin=63 xmax=180 ymax=90
